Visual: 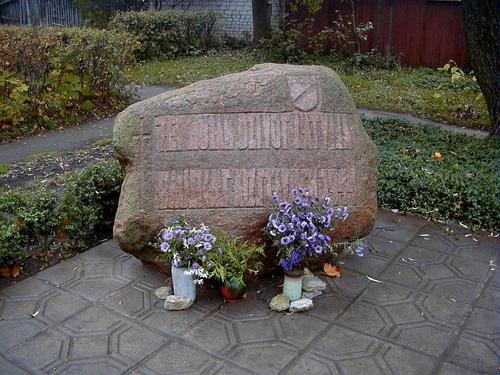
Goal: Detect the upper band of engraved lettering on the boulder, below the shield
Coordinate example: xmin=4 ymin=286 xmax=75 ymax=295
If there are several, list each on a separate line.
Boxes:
xmin=153 ymin=112 xmax=353 ymax=153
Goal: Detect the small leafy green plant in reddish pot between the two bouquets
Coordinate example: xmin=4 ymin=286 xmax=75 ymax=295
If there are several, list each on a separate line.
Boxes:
xmin=209 ymin=234 xmax=264 ymax=302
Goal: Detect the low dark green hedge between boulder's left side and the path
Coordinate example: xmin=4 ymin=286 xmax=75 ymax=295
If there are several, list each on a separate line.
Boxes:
xmin=0 ymin=161 xmax=123 ymax=266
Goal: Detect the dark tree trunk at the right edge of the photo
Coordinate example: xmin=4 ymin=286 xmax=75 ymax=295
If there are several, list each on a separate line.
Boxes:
xmin=463 ymin=0 xmax=500 ymax=136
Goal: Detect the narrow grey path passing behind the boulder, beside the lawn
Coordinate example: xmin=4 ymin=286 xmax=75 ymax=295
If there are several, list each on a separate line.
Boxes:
xmin=0 ymin=86 xmax=488 ymax=164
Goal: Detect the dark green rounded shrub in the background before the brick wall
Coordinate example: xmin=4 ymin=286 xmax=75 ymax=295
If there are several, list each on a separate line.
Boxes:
xmin=109 ymin=10 xmax=221 ymax=60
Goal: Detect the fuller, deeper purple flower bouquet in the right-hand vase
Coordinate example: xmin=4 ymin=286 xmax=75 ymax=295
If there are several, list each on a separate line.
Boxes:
xmin=266 ymin=188 xmax=348 ymax=271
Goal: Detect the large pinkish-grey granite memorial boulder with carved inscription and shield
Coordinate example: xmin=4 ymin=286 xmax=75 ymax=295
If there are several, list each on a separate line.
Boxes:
xmin=113 ymin=64 xmax=379 ymax=270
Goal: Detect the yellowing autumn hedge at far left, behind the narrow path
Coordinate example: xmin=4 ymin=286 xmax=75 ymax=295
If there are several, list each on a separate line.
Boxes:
xmin=0 ymin=26 xmax=140 ymax=141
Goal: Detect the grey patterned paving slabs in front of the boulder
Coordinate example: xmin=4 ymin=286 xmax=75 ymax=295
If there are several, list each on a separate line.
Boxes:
xmin=0 ymin=212 xmax=500 ymax=375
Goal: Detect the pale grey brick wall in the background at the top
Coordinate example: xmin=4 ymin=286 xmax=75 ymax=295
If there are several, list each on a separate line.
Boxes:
xmin=162 ymin=0 xmax=284 ymax=38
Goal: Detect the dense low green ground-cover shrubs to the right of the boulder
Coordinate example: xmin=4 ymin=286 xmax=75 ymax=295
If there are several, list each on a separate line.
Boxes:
xmin=363 ymin=119 xmax=500 ymax=231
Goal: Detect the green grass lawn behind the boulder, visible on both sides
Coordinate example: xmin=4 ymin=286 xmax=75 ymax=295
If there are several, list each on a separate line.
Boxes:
xmin=130 ymin=51 xmax=489 ymax=129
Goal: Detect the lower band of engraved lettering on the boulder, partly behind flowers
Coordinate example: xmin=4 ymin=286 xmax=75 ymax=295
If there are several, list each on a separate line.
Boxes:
xmin=155 ymin=168 xmax=356 ymax=210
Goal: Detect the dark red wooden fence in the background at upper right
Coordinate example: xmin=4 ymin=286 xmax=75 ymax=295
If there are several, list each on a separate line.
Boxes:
xmin=295 ymin=0 xmax=468 ymax=67
